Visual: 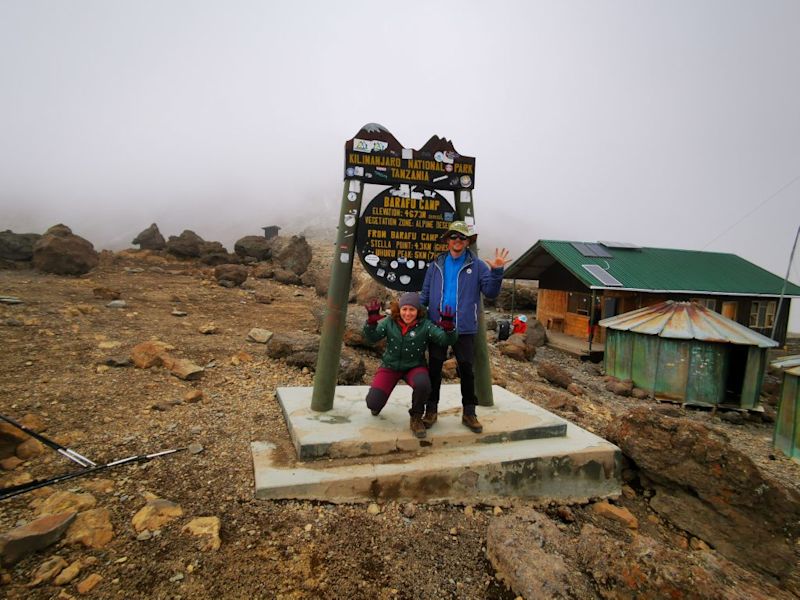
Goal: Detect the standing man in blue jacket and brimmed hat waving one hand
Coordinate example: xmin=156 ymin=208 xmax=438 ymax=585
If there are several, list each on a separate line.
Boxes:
xmin=420 ymin=221 xmax=509 ymax=433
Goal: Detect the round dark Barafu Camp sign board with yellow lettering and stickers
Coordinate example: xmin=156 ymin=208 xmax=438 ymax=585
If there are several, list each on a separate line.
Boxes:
xmin=356 ymin=185 xmax=455 ymax=292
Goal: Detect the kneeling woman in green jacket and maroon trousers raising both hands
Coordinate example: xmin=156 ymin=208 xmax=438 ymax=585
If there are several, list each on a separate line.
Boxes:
xmin=364 ymin=292 xmax=458 ymax=438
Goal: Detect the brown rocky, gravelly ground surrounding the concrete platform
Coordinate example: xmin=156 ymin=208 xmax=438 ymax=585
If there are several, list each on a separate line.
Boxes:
xmin=0 ymin=245 xmax=800 ymax=599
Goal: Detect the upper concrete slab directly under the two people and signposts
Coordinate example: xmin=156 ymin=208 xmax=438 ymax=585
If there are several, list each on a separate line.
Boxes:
xmin=277 ymin=385 xmax=567 ymax=460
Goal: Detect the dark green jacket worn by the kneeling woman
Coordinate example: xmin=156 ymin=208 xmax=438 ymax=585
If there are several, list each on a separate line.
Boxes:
xmin=364 ymin=317 xmax=458 ymax=371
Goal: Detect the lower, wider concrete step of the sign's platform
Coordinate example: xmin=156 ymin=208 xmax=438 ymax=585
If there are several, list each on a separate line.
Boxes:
xmin=252 ymin=425 xmax=621 ymax=503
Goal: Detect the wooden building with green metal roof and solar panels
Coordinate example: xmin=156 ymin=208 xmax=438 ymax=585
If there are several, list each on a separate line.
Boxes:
xmin=505 ymin=240 xmax=800 ymax=345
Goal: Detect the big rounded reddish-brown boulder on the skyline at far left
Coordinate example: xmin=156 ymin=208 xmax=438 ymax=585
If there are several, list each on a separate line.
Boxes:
xmin=33 ymin=224 xmax=100 ymax=275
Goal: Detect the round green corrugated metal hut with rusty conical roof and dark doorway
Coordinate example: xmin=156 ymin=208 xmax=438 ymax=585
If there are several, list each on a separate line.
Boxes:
xmin=600 ymin=300 xmax=778 ymax=408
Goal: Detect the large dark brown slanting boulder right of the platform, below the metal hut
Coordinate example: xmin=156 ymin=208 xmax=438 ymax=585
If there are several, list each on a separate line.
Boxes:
xmin=606 ymin=407 xmax=800 ymax=593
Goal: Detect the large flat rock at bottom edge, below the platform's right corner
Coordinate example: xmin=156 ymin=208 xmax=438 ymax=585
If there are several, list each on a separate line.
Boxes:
xmin=486 ymin=508 xmax=791 ymax=600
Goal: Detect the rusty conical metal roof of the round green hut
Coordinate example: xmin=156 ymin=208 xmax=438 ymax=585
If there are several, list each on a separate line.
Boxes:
xmin=600 ymin=300 xmax=778 ymax=348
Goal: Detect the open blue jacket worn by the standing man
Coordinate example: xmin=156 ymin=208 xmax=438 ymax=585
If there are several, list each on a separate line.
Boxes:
xmin=419 ymin=250 xmax=503 ymax=335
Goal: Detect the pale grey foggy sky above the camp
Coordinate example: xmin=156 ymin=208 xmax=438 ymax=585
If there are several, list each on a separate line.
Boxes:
xmin=0 ymin=0 xmax=800 ymax=331
